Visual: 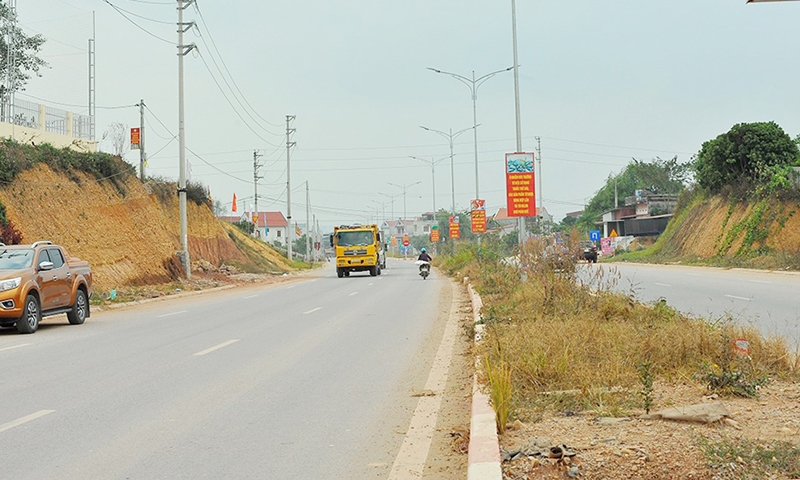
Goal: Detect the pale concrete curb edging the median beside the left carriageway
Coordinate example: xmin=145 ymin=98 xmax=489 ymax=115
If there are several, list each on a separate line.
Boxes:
xmin=467 ymin=284 xmax=503 ymax=480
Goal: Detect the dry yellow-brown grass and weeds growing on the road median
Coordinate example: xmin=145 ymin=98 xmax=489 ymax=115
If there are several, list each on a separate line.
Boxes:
xmin=464 ymin=241 xmax=798 ymax=414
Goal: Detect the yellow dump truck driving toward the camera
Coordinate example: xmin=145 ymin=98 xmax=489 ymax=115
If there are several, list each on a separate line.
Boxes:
xmin=331 ymin=224 xmax=386 ymax=278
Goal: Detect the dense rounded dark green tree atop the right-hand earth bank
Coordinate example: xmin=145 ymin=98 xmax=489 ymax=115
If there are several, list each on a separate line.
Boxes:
xmin=693 ymin=122 xmax=800 ymax=193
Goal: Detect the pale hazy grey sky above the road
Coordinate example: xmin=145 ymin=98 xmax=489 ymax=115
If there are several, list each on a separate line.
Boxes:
xmin=17 ymin=0 xmax=800 ymax=225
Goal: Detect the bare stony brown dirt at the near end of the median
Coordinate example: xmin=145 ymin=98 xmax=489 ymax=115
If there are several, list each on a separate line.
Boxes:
xmin=500 ymin=381 xmax=800 ymax=480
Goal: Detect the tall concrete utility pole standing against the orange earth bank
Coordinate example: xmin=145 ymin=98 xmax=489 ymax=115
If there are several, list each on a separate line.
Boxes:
xmin=178 ymin=0 xmax=196 ymax=278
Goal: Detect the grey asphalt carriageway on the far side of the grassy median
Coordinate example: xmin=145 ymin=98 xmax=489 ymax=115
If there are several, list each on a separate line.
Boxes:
xmin=581 ymin=263 xmax=800 ymax=342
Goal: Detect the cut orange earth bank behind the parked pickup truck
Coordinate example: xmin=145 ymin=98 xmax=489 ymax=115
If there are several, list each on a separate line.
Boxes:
xmin=0 ymin=142 xmax=292 ymax=290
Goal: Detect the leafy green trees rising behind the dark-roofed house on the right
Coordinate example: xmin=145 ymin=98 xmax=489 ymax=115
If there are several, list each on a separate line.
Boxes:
xmin=576 ymin=157 xmax=691 ymax=232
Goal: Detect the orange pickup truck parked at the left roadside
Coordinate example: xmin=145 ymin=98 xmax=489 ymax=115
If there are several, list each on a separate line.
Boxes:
xmin=0 ymin=241 xmax=92 ymax=333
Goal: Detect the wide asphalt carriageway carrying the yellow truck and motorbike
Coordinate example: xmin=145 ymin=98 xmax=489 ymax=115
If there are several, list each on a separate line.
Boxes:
xmin=0 ymin=261 xmax=449 ymax=480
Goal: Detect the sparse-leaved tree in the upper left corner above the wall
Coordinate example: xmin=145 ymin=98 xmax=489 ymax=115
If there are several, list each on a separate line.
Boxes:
xmin=0 ymin=2 xmax=48 ymax=97
